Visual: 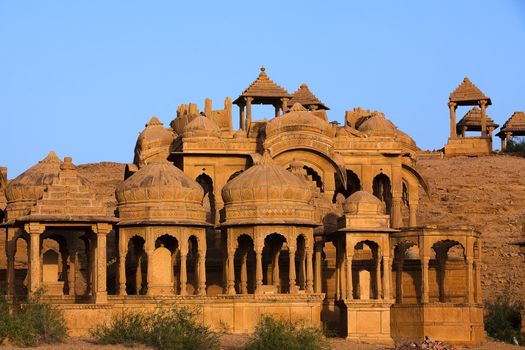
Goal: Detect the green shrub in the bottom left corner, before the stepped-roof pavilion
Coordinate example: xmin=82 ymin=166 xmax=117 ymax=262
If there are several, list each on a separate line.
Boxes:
xmin=0 ymin=291 xmax=67 ymax=347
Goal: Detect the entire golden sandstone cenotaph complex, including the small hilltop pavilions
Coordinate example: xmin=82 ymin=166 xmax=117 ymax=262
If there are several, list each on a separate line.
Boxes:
xmin=0 ymin=68 xmax=525 ymax=345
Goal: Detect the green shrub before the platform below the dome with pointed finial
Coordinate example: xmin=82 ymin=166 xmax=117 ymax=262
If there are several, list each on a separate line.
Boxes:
xmin=246 ymin=316 xmax=327 ymax=350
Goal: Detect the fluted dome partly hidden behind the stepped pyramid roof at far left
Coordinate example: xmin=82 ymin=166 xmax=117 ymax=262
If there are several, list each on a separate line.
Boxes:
xmin=5 ymin=151 xmax=62 ymax=220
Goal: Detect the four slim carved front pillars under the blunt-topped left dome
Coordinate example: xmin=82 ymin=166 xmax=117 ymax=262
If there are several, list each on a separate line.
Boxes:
xmin=118 ymin=238 xmax=206 ymax=296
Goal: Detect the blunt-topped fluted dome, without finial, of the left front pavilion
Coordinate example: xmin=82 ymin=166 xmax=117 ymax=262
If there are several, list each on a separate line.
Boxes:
xmin=115 ymin=161 xmax=206 ymax=224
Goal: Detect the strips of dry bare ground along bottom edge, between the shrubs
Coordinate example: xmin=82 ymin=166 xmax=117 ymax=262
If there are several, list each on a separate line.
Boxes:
xmin=2 ymin=334 xmax=523 ymax=350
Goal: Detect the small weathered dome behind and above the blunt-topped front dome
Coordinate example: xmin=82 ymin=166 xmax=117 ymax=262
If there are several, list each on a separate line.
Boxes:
xmin=133 ymin=117 xmax=175 ymax=167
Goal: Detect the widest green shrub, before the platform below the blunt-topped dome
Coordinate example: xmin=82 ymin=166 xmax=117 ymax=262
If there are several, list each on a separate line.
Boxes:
xmin=91 ymin=308 xmax=218 ymax=350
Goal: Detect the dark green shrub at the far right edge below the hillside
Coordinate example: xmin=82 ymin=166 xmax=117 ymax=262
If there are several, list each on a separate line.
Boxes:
xmin=485 ymin=295 xmax=525 ymax=344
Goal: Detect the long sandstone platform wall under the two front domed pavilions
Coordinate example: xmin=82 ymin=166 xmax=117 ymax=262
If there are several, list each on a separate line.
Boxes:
xmin=51 ymin=294 xmax=324 ymax=336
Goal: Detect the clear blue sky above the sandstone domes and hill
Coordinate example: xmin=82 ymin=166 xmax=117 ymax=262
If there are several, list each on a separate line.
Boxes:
xmin=0 ymin=0 xmax=525 ymax=178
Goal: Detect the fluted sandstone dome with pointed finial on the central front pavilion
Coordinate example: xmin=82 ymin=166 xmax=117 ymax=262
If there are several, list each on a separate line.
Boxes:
xmin=222 ymin=152 xmax=314 ymax=224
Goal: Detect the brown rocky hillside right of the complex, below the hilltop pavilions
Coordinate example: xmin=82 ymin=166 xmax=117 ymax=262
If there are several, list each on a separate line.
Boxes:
xmin=417 ymin=155 xmax=525 ymax=300
